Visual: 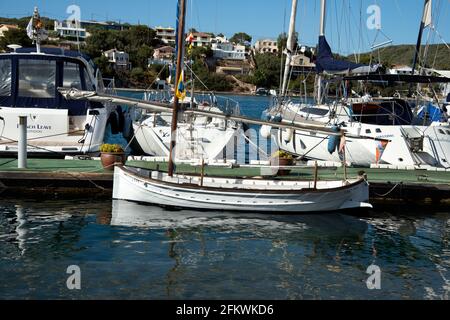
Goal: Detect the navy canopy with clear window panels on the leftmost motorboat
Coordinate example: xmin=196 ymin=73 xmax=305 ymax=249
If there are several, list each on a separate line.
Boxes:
xmin=0 ymin=48 xmax=103 ymax=116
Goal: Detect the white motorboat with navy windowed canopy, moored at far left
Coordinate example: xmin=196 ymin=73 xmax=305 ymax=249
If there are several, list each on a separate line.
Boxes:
xmin=0 ymin=10 xmax=129 ymax=157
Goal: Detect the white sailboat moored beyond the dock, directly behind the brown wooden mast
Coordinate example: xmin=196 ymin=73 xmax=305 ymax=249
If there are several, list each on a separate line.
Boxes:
xmin=133 ymin=20 xmax=245 ymax=162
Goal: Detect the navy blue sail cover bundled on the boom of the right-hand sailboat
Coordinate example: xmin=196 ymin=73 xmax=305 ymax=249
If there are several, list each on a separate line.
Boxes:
xmin=316 ymin=36 xmax=378 ymax=74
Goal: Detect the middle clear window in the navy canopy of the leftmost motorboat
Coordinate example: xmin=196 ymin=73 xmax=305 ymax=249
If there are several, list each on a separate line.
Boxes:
xmin=19 ymin=59 xmax=56 ymax=98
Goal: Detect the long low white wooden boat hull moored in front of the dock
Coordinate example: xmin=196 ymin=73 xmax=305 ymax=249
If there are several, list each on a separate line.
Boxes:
xmin=113 ymin=167 xmax=371 ymax=213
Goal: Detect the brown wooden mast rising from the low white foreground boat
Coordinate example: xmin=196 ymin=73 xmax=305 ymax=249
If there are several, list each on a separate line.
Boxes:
xmin=169 ymin=0 xmax=186 ymax=177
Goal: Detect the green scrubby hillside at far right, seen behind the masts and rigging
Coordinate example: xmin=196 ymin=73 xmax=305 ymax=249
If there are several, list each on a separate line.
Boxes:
xmin=349 ymin=45 xmax=450 ymax=70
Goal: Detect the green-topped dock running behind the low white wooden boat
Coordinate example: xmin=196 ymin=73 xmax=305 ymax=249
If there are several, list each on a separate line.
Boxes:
xmin=0 ymin=159 xmax=450 ymax=204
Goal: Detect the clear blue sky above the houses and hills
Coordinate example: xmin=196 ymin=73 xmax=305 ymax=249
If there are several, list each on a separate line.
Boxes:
xmin=0 ymin=0 xmax=450 ymax=54
